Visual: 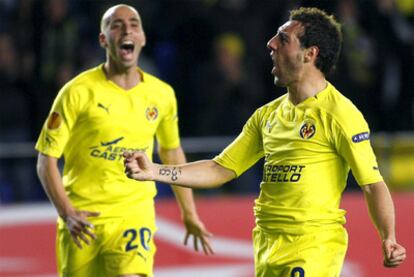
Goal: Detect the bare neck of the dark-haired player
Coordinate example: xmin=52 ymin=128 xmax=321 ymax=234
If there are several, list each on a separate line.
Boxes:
xmin=288 ymin=68 xmax=327 ymax=105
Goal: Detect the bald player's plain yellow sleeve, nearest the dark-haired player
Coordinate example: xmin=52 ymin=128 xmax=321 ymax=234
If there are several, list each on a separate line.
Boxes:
xmin=155 ymin=88 xmax=180 ymax=149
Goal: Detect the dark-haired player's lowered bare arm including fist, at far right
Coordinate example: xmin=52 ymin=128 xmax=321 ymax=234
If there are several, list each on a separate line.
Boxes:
xmin=361 ymin=182 xmax=406 ymax=267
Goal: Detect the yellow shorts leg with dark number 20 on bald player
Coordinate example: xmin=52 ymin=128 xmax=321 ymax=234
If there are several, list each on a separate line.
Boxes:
xmin=102 ymin=216 xmax=156 ymax=276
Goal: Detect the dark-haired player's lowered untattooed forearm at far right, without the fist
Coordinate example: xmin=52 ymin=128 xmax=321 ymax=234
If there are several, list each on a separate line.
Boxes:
xmin=362 ymin=182 xmax=395 ymax=241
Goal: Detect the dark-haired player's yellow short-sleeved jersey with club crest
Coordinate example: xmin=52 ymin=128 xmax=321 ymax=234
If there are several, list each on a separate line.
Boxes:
xmin=215 ymin=83 xmax=382 ymax=234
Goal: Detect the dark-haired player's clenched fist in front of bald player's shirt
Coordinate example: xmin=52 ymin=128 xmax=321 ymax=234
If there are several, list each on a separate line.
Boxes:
xmin=123 ymin=151 xmax=155 ymax=181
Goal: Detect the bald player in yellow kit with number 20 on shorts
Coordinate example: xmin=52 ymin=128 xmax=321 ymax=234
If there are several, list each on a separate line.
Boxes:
xmin=36 ymin=5 xmax=213 ymax=277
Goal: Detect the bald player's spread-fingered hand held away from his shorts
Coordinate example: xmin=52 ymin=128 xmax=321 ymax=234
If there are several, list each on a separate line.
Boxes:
xmin=183 ymin=213 xmax=214 ymax=255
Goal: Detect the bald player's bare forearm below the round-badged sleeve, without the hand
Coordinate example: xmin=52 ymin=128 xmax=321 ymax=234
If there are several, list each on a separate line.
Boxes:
xmin=37 ymin=154 xmax=73 ymax=219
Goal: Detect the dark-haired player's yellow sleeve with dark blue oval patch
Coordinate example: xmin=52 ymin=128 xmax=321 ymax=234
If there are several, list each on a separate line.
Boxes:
xmin=332 ymin=108 xmax=383 ymax=186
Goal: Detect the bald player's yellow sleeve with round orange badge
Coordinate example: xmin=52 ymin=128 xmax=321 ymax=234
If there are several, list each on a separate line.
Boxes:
xmin=35 ymin=82 xmax=81 ymax=158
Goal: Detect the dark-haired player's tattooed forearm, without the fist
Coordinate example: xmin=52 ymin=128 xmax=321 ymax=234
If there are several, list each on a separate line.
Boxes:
xmin=154 ymin=160 xmax=235 ymax=189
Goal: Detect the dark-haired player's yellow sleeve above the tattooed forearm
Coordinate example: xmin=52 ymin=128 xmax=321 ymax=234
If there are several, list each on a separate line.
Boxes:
xmin=214 ymin=111 xmax=264 ymax=177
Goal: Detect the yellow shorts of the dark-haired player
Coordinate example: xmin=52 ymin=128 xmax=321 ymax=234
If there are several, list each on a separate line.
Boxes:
xmin=254 ymin=227 xmax=348 ymax=277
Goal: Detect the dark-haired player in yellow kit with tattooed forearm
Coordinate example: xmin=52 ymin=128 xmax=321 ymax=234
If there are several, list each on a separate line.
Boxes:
xmin=124 ymin=5 xmax=406 ymax=277
